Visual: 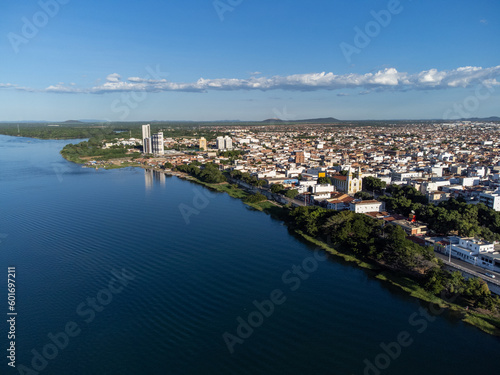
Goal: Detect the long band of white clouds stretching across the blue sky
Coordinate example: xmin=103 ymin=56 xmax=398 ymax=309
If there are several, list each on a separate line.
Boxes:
xmin=0 ymin=65 xmax=500 ymax=95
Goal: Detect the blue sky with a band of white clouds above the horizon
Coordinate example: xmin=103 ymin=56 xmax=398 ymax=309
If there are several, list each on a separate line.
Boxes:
xmin=0 ymin=0 xmax=500 ymax=121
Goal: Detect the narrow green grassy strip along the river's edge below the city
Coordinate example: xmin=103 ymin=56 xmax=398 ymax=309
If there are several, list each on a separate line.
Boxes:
xmin=61 ymin=154 xmax=500 ymax=336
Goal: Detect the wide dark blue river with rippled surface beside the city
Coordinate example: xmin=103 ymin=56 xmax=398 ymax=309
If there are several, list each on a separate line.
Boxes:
xmin=0 ymin=136 xmax=500 ymax=375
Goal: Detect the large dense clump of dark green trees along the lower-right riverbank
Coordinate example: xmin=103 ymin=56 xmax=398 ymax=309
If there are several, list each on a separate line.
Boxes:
xmin=290 ymin=207 xmax=500 ymax=312
